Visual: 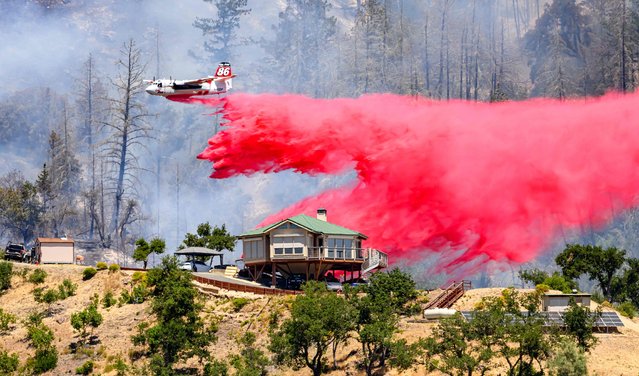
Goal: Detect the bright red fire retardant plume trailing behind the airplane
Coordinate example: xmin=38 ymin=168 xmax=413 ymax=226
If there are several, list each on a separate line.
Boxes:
xmin=189 ymin=94 xmax=639 ymax=271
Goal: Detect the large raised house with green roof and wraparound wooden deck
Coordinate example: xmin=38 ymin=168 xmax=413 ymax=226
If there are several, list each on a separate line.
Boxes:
xmin=238 ymin=209 xmax=388 ymax=286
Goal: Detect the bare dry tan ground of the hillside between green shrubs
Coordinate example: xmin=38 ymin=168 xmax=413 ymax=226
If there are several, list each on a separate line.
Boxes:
xmin=0 ymin=264 xmax=639 ymax=376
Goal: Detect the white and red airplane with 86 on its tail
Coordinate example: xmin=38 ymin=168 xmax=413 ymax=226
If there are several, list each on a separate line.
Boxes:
xmin=144 ymin=62 xmax=235 ymax=98
